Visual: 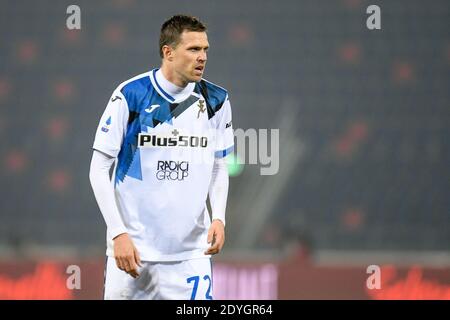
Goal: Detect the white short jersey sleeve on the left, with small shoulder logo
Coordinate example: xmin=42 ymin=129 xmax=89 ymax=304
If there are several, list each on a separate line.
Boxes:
xmin=93 ymin=90 xmax=129 ymax=158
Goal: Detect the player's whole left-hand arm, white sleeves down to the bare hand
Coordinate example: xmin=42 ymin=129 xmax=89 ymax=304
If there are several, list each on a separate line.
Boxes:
xmin=89 ymin=90 xmax=140 ymax=277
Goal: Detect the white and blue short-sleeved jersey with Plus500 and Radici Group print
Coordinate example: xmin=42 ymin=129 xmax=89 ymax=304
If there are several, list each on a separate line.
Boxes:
xmin=93 ymin=69 xmax=234 ymax=261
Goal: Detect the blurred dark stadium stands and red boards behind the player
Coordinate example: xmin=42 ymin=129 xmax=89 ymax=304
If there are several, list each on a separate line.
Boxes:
xmin=0 ymin=0 xmax=450 ymax=299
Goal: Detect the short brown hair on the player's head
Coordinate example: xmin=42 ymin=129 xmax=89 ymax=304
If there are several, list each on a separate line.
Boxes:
xmin=159 ymin=14 xmax=206 ymax=58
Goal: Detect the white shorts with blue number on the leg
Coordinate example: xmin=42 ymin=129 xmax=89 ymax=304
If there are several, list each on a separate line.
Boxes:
xmin=104 ymin=257 xmax=212 ymax=300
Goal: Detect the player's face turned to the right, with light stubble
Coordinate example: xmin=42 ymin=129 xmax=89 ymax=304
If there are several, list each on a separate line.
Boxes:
xmin=173 ymin=31 xmax=209 ymax=83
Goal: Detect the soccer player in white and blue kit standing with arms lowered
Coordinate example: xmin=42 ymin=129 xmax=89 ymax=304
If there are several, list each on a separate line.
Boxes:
xmin=89 ymin=15 xmax=234 ymax=300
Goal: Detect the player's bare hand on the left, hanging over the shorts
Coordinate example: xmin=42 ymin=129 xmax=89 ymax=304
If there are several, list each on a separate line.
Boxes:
xmin=113 ymin=233 xmax=141 ymax=278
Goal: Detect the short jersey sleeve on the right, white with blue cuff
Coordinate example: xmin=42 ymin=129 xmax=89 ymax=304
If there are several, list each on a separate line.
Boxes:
xmin=215 ymin=96 xmax=234 ymax=158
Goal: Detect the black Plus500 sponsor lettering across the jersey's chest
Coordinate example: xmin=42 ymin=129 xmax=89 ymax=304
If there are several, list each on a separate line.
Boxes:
xmin=138 ymin=133 xmax=208 ymax=148
